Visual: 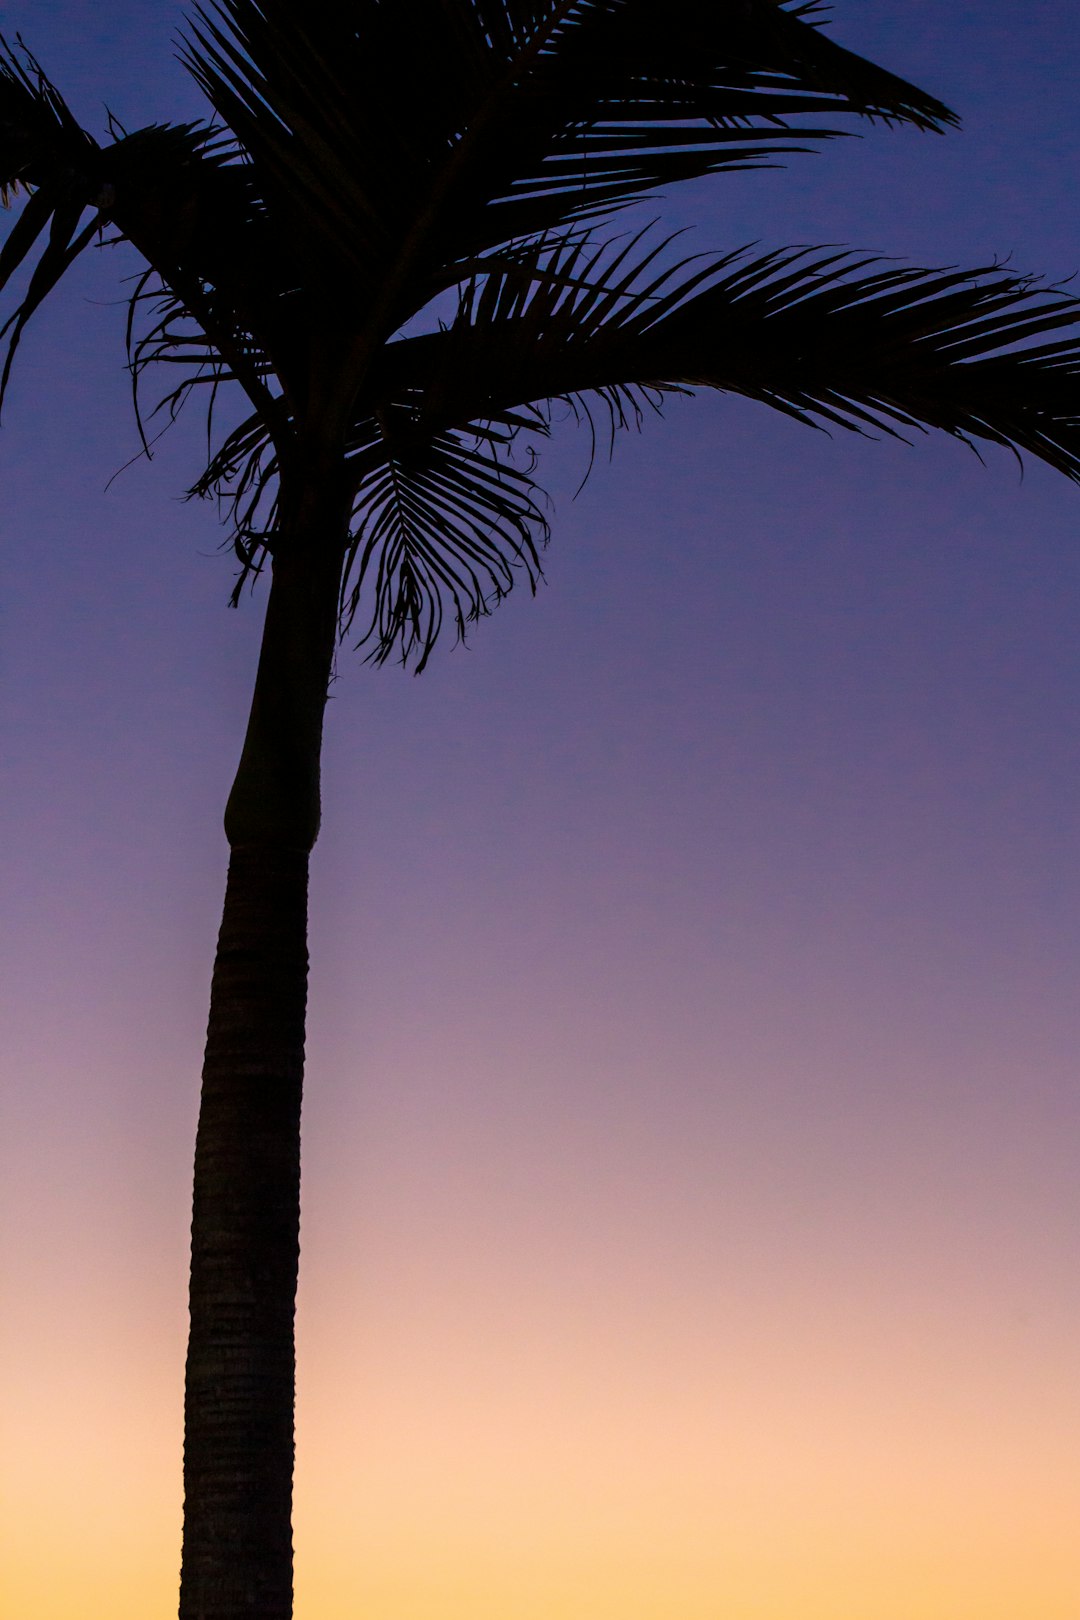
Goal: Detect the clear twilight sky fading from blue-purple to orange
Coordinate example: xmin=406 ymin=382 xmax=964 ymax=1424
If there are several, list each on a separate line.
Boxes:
xmin=0 ymin=0 xmax=1080 ymax=1620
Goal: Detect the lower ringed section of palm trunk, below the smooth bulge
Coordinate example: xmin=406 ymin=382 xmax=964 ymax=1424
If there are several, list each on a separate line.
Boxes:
xmin=180 ymin=846 xmax=308 ymax=1620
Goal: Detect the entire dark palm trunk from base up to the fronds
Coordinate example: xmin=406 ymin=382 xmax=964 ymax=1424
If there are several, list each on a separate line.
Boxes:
xmin=180 ymin=483 xmax=345 ymax=1620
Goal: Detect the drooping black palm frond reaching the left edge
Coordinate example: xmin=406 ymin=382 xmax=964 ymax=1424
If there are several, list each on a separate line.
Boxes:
xmin=0 ymin=41 xmax=301 ymax=416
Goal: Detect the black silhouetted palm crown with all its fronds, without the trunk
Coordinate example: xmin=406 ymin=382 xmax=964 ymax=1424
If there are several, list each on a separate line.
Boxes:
xmin=0 ymin=0 xmax=1080 ymax=666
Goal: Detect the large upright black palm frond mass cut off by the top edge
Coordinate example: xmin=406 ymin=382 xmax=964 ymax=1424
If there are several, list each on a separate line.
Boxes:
xmin=185 ymin=0 xmax=955 ymax=340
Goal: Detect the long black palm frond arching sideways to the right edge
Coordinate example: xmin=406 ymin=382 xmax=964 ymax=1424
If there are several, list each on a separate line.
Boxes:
xmin=375 ymin=236 xmax=1080 ymax=478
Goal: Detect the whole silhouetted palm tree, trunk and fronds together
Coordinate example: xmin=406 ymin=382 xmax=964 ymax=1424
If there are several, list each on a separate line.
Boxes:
xmin=0 ymin=0 xmax=1080 ymax=1620
